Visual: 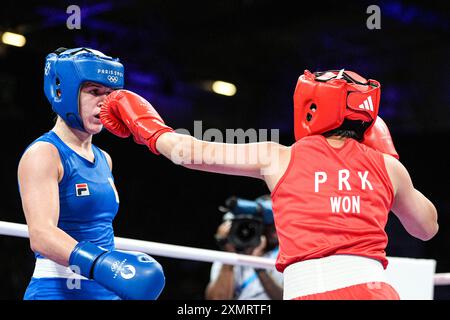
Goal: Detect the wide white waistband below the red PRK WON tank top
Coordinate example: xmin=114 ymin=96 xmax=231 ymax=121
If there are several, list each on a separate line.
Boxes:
xmin=283 ymin=255 xmax=386 ymax=300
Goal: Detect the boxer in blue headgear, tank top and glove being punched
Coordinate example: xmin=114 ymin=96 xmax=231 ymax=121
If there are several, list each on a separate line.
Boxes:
xmin=18 ymin=48 xmax=165 ymax=300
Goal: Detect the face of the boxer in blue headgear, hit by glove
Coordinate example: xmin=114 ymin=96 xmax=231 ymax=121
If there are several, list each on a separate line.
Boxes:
xmin=80 ymin=82 xmax=113 ymax=134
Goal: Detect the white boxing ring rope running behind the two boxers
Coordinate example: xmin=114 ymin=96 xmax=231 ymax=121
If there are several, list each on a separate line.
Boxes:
xmin=0 ymin=221 xmax=450 ymax=286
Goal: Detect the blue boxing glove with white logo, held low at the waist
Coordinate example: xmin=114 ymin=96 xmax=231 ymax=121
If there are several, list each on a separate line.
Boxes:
xmin=69 ymin=241 xmax=165 ymax=300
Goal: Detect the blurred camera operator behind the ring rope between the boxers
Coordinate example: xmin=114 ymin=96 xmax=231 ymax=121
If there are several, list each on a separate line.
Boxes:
xmin=206 ymin=196 xmax=283 ymax=300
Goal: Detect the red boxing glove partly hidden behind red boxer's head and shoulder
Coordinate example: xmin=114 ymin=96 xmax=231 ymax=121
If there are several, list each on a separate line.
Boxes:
xmin=362 ymin=117 xmax=399 ymax=159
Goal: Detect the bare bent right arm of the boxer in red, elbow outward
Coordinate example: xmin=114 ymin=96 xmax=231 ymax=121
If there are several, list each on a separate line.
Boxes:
xmin=384 ymin=155 xmax=439 ymax=241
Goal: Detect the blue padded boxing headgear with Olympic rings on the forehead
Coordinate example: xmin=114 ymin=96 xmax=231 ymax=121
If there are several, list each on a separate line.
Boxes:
xmin=44 ymin=48 xmax=124 ymax=131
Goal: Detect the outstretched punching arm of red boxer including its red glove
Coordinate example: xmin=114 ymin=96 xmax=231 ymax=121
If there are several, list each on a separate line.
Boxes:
xmin=100 ymin=90 xmax=290 ymax=189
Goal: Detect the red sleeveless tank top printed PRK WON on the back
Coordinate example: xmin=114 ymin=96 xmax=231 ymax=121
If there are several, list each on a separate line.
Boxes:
xmin=272 ymin=135 xmax=394 ymax=272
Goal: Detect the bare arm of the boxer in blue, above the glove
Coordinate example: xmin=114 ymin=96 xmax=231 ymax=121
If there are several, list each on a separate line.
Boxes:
xmin=18 ymin=142 xmax=77 ymax=266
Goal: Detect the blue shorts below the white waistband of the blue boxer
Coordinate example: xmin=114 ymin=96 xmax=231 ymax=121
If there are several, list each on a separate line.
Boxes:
xmin=23 ymin=278 xmax=120 ymax=300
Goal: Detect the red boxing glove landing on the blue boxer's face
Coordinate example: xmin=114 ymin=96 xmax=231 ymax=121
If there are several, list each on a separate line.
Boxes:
xmin=100 ymin=90 xmax=173 ymax=154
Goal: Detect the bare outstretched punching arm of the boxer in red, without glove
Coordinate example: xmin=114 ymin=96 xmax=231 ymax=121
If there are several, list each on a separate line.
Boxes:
xmin=156 ymin=132 xmax=288 ymax=179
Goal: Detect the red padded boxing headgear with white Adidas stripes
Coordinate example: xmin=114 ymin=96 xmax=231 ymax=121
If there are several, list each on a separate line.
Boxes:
xmin=294 ymin=69 xmax=381 ymax=140
